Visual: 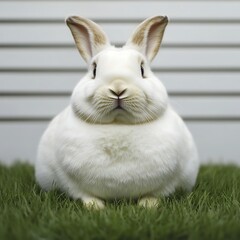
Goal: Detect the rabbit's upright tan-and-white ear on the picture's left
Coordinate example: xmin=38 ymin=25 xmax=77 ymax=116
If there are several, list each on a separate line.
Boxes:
xmin=66 ymin=16 xmax=110 ymax=62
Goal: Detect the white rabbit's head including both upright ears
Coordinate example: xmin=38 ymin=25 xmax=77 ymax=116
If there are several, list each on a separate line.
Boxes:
xmin=66 ymin=16 xmax=168 ymax=124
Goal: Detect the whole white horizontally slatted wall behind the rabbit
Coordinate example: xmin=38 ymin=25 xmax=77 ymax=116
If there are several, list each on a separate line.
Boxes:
xmin=0 ymin=0 xmax=240 ymax=164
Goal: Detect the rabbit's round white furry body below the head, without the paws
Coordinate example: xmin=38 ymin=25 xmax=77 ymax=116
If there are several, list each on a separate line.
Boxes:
xmin=36 ymin=107 xmax=198 ymax=199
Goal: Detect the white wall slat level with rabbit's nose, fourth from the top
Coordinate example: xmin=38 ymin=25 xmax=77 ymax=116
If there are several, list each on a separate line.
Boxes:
xmin=0 ymin=72 xmax=240 ymax=93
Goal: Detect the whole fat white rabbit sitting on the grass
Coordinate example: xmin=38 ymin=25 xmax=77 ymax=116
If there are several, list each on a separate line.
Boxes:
xmin=35 ymin=16 xmax=199 ymax=208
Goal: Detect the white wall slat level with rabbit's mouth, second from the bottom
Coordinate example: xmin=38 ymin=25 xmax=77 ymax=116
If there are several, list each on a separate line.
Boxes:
xmin=0 ymin=96 xmax=240 ymax=119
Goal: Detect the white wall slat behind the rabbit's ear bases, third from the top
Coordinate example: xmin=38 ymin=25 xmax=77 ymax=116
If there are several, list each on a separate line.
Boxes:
xmin=0 ymin=48 xmax=240 ymax=70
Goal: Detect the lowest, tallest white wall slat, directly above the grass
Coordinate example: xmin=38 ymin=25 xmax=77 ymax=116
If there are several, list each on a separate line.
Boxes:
xmin=0 ymin=122 xmax=240 ymax=165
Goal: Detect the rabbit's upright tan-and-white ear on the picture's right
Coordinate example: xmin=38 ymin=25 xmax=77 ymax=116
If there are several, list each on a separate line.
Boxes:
xmin=126 ymin=16 xmax=168 ymax=62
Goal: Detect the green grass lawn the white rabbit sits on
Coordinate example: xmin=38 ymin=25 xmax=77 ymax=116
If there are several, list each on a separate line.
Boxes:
xmin=0 ymin=164 xmax=240 ymax=240
